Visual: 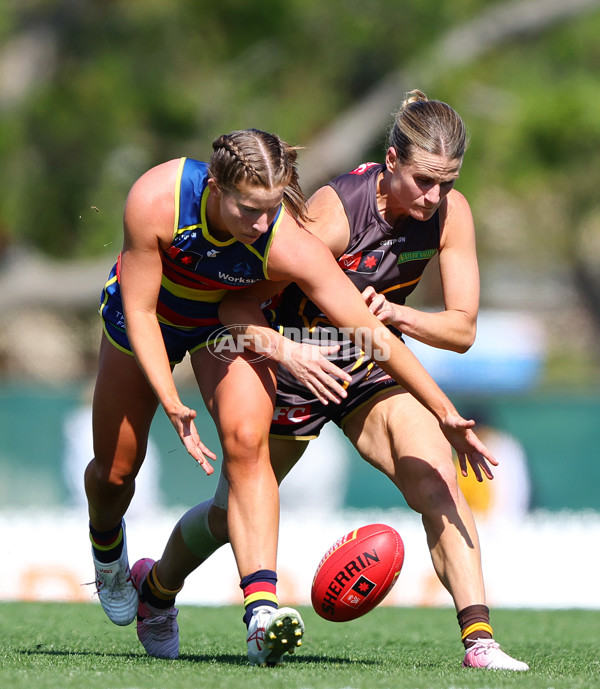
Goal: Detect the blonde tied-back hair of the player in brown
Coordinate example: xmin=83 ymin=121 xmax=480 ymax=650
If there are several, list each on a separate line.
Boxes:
xmin=389 ymin=89 xmax=468 ymax=163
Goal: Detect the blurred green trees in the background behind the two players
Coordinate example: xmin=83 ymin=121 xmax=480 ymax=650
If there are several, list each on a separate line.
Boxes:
xmin=0 ymin=0 xmax=600 ymax=385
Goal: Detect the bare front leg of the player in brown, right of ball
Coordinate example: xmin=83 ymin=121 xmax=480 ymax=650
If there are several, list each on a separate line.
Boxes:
xmin=344 ymin=391 xmax=485 ymax=611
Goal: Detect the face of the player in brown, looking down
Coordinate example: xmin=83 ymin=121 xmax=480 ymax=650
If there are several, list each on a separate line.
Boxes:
xmin=386 ymin=147 xmax=462 ymax=220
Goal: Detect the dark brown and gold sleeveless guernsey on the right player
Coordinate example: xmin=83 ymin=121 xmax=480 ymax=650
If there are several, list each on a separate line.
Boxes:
xmin=277 ymin=163 xmax=440 ymax=361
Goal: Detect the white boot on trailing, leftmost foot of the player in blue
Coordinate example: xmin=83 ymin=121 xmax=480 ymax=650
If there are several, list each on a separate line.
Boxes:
xmin=92 ymin=521 xmax=138 ymax=627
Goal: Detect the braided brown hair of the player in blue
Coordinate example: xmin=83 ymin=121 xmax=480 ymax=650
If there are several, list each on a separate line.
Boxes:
xmin=208 ymin=129 xmax=307 ymax=221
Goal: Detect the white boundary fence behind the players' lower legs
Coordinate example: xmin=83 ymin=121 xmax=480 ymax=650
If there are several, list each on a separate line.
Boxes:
xmin=0 ymin=510 xmax=600 ymax=609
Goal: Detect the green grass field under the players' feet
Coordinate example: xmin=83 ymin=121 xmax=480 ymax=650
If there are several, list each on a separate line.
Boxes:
xmin=0 ymin=603 xmax=600 ymax=689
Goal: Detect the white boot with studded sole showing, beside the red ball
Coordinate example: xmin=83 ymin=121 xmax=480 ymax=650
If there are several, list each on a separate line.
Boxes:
xmin=246 ymin=605 xmax=304 ymax=667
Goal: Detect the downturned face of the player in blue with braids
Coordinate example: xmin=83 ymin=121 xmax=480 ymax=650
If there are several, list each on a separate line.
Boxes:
xmin=211 ymin=180 xmax=285 ymax=244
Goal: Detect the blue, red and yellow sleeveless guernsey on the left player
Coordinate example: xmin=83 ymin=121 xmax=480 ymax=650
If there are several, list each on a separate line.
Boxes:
xmin=100 ymin=158 xmax=284 ymax=361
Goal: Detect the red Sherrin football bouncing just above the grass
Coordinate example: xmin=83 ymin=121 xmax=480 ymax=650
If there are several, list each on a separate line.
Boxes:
xmin=311 ymin=524 xmax=404 ymax=622
